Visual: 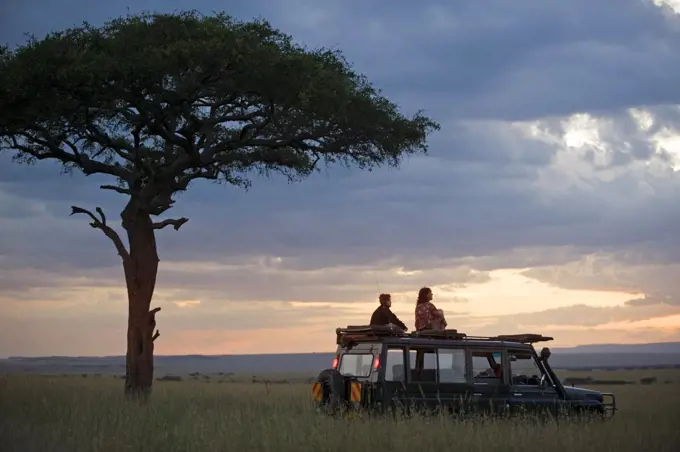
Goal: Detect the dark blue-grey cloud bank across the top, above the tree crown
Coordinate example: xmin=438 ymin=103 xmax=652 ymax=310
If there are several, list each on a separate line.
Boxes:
xmin=0 ymin=0 xmax=680 ymax=119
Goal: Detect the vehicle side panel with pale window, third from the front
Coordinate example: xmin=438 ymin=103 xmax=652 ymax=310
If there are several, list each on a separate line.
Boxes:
xmin=437 ymin=347 xmax=473 ymax=413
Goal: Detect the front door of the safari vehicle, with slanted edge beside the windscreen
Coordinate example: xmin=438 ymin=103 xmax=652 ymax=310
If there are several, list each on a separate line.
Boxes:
xmin=508 ymin=349 xmax=564 ymax=414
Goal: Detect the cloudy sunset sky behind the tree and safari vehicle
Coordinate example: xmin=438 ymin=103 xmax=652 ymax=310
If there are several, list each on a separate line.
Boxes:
xmin=0 ymin=0 xmax=680 ymax=356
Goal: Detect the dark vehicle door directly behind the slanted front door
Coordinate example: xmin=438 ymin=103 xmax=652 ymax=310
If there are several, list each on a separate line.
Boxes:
xmin=467 ymin=348 xmax=510 ymax=413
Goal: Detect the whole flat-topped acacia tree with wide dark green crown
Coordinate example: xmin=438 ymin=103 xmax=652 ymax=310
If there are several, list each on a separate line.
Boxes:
xmin=0 ymin=11 xmax=439 ymax=395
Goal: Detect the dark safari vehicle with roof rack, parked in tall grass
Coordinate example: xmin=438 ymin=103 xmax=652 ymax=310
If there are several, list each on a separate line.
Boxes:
xmin=312 ymin=326 xmax=616 ymax=417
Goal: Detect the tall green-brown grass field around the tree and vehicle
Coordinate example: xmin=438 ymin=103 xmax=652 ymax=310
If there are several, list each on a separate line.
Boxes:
xmin=0 ymin=371 xmax=680 ymax=452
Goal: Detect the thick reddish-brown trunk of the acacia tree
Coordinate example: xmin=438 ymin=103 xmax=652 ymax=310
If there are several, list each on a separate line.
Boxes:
xmin=121 ymin=201 xmax=160 ymax=400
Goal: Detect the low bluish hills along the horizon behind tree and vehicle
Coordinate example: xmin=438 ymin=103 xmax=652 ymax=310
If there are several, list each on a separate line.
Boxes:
xmin=0 ymin=342 xmax=680 ymax=375
